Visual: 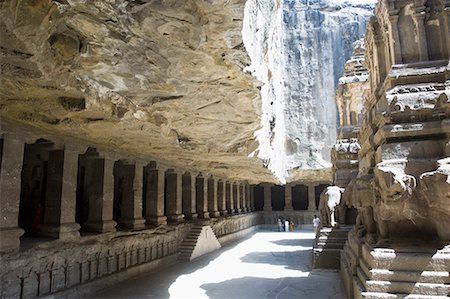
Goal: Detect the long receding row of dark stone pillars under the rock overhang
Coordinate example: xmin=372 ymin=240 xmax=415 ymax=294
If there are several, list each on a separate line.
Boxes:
xmin=0 ymin=133 xmax=255 ymax=252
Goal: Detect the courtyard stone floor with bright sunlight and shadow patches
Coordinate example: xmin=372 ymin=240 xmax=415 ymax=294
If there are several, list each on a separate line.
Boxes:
xmin=90 ymin=230 xmax=343 ymax=299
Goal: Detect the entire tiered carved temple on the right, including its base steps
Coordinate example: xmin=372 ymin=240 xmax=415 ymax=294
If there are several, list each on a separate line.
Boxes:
xmin=341 ymin=0 xmax=450 ymax=298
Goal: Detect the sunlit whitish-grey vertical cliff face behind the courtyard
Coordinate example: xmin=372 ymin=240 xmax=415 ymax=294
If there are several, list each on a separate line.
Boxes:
xmin=243 ymin=0 xmax=372 ymax=181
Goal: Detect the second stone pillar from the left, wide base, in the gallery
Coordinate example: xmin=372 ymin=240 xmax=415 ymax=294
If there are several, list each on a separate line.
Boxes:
xmin=39 ymin=149 xmax=80 ymax=239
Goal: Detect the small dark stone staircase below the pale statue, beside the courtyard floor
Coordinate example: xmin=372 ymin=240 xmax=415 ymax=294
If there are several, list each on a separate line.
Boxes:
xmin=312 ymin=226 xmax=353 ymax=269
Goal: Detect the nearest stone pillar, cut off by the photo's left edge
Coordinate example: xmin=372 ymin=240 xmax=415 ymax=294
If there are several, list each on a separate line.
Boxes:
xmin=0 ymin=134 xmax=25 ymax=252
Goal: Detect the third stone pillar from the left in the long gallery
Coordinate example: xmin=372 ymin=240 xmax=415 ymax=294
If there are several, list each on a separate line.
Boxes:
xmin=84 ymin=157 xmax=116 ymax=233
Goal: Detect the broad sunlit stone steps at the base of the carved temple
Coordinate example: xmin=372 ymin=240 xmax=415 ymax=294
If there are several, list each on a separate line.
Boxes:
xmin=341 ymin=233 xmax=450 ymax=299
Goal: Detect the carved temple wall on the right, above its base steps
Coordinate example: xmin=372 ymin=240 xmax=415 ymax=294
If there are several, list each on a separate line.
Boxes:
xmin=344 ymin=1 xmax=450 ymax=244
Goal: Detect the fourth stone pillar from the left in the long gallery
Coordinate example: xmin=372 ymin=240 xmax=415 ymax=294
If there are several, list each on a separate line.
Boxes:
xmin=119 ymin=162 xmax=145 ymax=230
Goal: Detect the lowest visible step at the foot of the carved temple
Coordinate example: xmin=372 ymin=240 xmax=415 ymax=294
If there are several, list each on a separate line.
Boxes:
xmin=357 ymin=267 xmax=450 ymax=296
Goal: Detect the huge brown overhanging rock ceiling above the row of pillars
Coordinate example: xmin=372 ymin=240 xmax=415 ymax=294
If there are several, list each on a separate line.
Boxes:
xmin=0 ymin=0 xmax=275 ymax=181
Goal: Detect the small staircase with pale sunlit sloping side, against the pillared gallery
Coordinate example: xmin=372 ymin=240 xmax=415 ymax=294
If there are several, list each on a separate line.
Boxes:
xmin=178 ymin=223 xmax=221 ymax=262
